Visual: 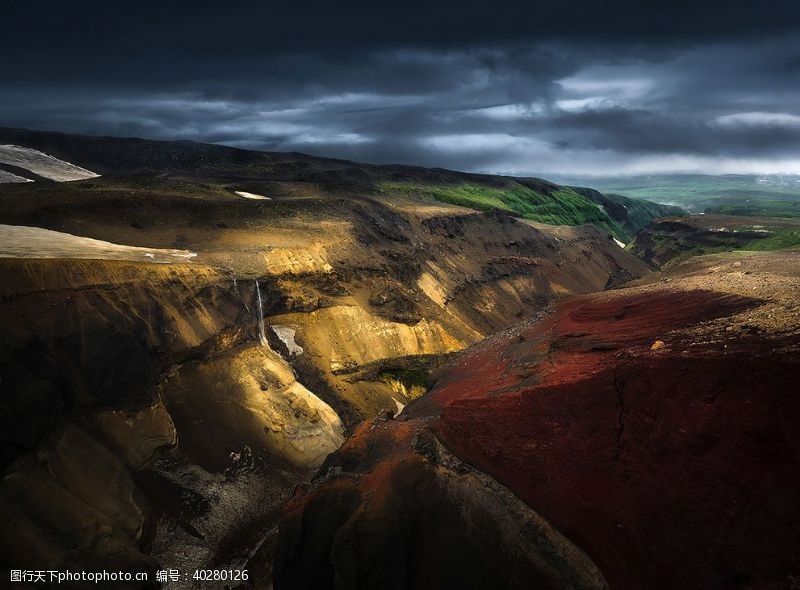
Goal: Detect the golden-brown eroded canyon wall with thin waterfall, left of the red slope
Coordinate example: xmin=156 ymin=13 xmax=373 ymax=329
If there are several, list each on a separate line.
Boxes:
xmin=0 ymin=131 xmax=648 ymax=579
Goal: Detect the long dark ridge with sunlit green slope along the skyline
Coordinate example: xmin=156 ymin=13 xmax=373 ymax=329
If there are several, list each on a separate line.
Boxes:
xmin=0 ymin=128 xmax=681 ymax=242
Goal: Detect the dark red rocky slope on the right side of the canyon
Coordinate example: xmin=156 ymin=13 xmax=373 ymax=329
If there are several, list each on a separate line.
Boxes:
xmin=276 ymin=253 xmax=800 ymax=589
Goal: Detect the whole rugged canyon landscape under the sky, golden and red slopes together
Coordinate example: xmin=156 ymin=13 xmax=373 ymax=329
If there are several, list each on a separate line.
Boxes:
xmin=0 ymin=129 xmax=800 ymax=590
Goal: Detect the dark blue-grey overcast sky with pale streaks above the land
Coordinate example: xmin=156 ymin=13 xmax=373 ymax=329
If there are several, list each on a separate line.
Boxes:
xmin=0 ymin=0 xmax=800 ymax=176
